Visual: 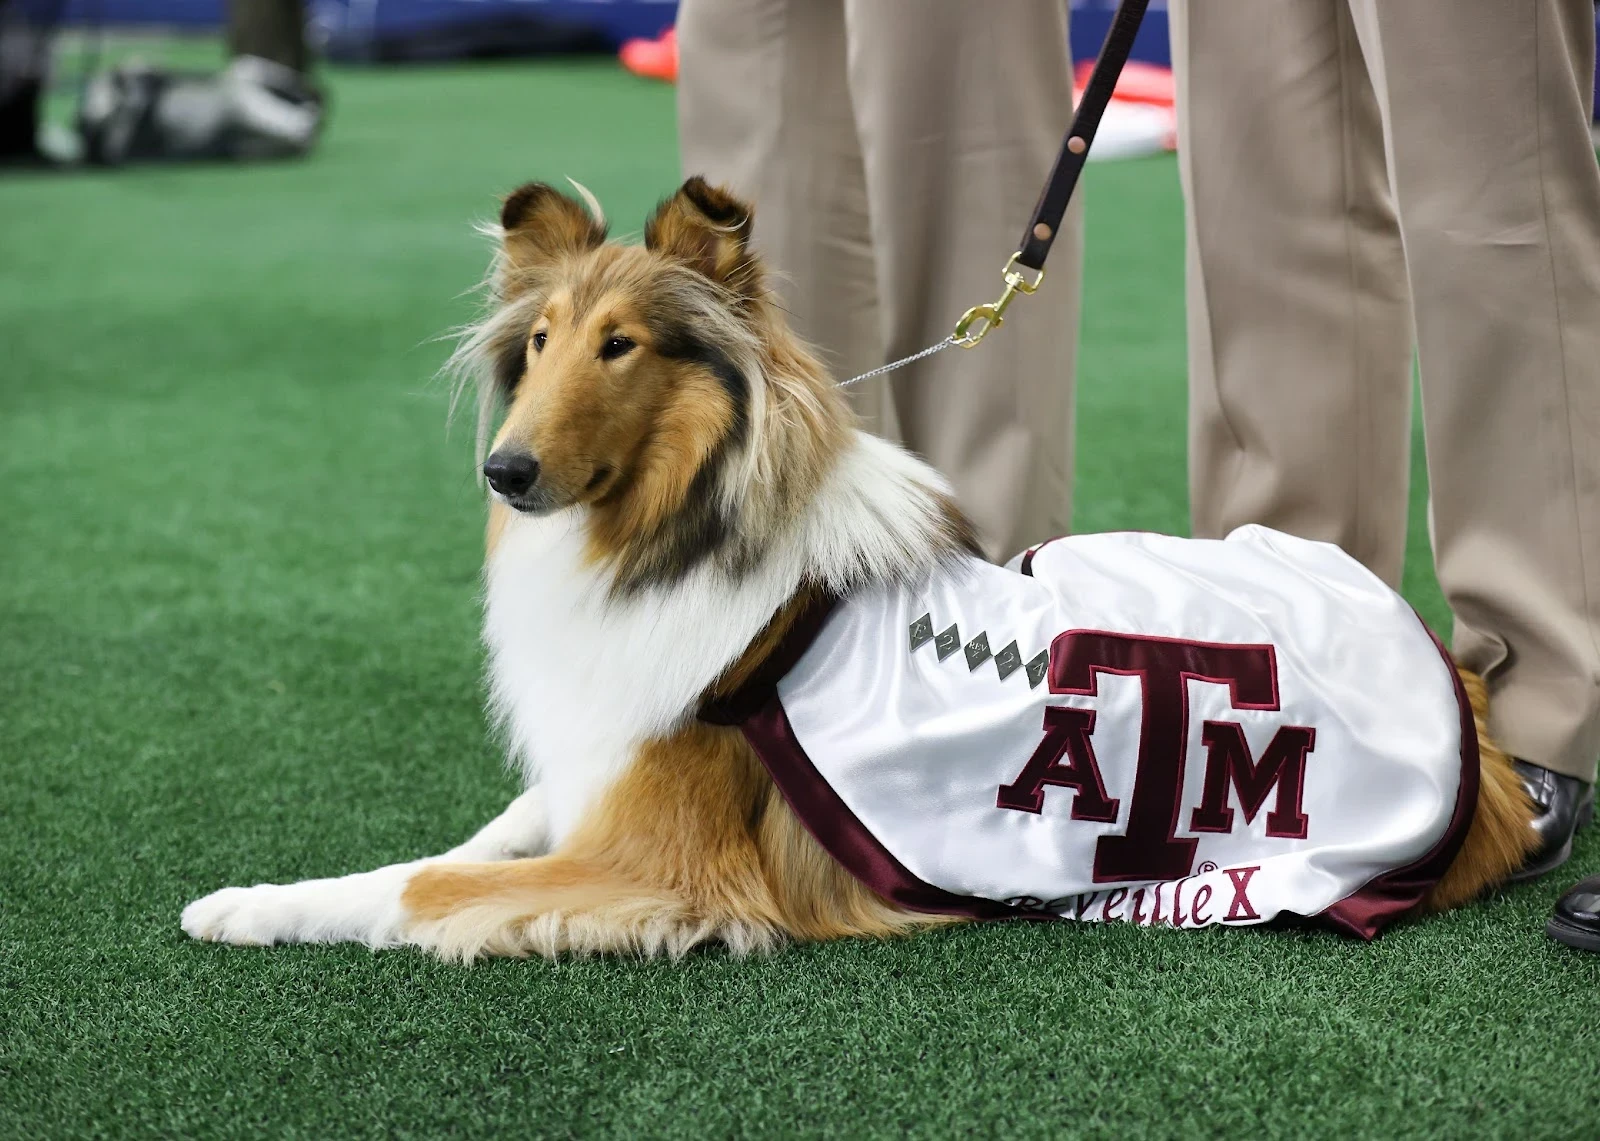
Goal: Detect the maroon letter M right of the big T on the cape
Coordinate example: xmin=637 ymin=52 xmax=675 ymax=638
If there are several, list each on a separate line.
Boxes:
xmin=1189 ymin=722 xmax=1317 ymax=840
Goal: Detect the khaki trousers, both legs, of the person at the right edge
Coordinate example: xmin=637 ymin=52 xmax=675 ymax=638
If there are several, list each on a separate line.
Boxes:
xmin=1174 ymin=0 xmax=1600 ymax=778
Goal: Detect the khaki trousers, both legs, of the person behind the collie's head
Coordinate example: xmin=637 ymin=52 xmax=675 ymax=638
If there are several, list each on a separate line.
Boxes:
xmin=678 ymin=0 xmax=1082 ymax=555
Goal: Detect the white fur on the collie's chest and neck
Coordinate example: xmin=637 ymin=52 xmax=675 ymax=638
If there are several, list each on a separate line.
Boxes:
xmin=483 ymin=434 xmax=947 ymax=843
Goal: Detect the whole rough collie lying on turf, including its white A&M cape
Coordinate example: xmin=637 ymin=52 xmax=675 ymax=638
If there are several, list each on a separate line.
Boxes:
xmin=182 ymin=179 xmax=1534 ymax=959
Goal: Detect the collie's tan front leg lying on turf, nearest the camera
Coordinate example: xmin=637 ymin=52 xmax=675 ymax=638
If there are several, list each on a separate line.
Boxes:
xmin=402 ymin=796 xmax=960 ymax=960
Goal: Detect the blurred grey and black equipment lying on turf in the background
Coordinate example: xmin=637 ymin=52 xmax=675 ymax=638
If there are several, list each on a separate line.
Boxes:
xmin=78 ymin=56 xmax=325 ymax=165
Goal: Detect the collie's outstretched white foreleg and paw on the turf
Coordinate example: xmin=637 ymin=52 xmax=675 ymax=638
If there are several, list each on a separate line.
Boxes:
xmin=182 ymin=787 xmax=549 ymax=947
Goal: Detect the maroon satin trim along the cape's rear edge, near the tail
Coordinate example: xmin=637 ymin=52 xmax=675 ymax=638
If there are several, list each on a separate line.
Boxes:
xmin=1317 ymin=615 xmax=1480 ymax=939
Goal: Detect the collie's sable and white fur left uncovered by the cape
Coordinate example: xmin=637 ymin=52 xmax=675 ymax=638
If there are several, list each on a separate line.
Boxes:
xmin=182 ymin=179 xmax=1531 ymax=959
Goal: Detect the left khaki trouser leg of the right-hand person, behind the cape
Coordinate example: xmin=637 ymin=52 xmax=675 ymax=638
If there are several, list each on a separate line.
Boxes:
xmin=1171 ymin=0 xmax=1411 ymax=586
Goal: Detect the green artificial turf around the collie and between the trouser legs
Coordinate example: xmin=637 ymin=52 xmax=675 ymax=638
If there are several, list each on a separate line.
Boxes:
xmin=0 ymin=55 xmax=1600 ymax=1138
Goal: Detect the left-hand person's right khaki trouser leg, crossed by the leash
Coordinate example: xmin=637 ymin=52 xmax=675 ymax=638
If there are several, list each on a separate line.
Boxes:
xmin=845 ymin=0 xmax=1083 ymax=557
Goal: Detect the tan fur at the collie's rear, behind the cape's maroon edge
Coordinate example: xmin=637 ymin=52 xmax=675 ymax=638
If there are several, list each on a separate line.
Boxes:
xmin=1426 ymin=669 xmax=1538 ymax=911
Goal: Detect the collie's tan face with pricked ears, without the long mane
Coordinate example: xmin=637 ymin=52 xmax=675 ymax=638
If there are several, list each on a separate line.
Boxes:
xmin=483 ymin=178 xmax=763 ymax=517
